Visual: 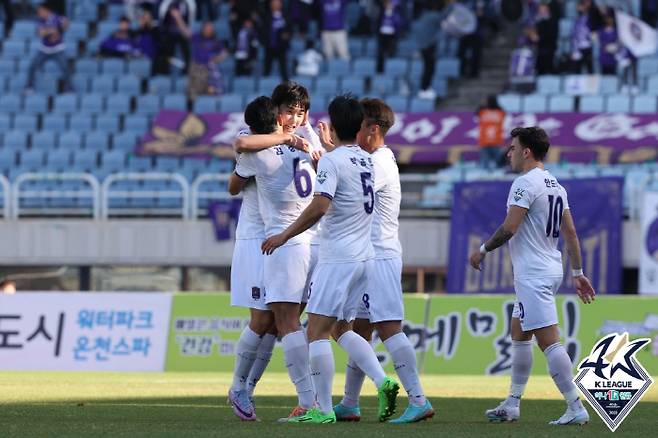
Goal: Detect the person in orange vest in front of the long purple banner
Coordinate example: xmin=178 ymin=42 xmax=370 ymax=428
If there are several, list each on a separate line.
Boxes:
xmin=477 ymin=96 xmax=505 ymax=169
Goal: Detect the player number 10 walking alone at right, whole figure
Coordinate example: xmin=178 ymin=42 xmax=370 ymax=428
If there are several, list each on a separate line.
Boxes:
xmin=470 ymin=127 xmax=595 ymax=425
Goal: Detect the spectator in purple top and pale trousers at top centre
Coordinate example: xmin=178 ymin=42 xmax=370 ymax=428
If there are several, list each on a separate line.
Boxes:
xmin=318 ymin=0 xmax=350 ymax=60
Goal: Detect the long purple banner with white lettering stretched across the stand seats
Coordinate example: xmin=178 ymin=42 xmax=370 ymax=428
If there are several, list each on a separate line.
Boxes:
xmin=138 ymin=110 xmax=658 ymax=164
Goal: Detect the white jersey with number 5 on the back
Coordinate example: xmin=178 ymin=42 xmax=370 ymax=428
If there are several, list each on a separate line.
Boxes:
xmin=315 ymin=145 xmax=375 ymax=263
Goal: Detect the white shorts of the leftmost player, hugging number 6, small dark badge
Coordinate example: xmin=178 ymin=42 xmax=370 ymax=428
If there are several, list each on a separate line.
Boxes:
xmin=231 ymin=239 xmax=269 ymax=310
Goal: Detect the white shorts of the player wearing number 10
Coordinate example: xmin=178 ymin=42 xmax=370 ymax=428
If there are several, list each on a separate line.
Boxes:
xmin=512 ymin=277 xmax=562 ymax=332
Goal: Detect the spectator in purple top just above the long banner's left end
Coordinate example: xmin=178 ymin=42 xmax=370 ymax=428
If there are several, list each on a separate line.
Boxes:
xmin=189 ymin=21 xmax=227 ymax=99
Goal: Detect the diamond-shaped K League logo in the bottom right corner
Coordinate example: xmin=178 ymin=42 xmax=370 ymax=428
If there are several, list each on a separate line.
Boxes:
xmin=574 ymin=333 xmax=653 ymax=432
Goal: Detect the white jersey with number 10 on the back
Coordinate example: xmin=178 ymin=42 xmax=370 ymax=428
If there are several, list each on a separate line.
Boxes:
xmin=507 ymin=168 xmax=569 ymax=279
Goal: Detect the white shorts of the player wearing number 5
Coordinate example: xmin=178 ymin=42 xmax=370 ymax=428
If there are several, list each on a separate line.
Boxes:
xmin=306 ymin=260 xmax=372 ymax=321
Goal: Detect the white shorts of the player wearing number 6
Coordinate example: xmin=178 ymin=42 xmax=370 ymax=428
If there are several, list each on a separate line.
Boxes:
xmin=263 ymin=243 xmax=311 ymax=304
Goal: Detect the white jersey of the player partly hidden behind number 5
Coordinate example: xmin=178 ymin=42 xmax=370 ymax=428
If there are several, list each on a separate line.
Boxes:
xmin=371 ymin=147 xmax=402 ymax=259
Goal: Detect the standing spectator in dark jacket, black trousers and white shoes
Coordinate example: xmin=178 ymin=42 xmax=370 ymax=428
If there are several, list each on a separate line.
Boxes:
xmin=413 ymin=0 xmax=444 ymax=100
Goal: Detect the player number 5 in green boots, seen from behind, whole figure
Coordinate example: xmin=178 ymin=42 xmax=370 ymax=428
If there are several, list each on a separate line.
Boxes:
xmin=262 ymin=95 xmax=399 ymax=423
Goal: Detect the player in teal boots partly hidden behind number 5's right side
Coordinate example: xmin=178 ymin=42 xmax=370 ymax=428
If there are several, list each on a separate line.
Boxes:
xmin=334 ymin=99 xmax=434 ymax=423
